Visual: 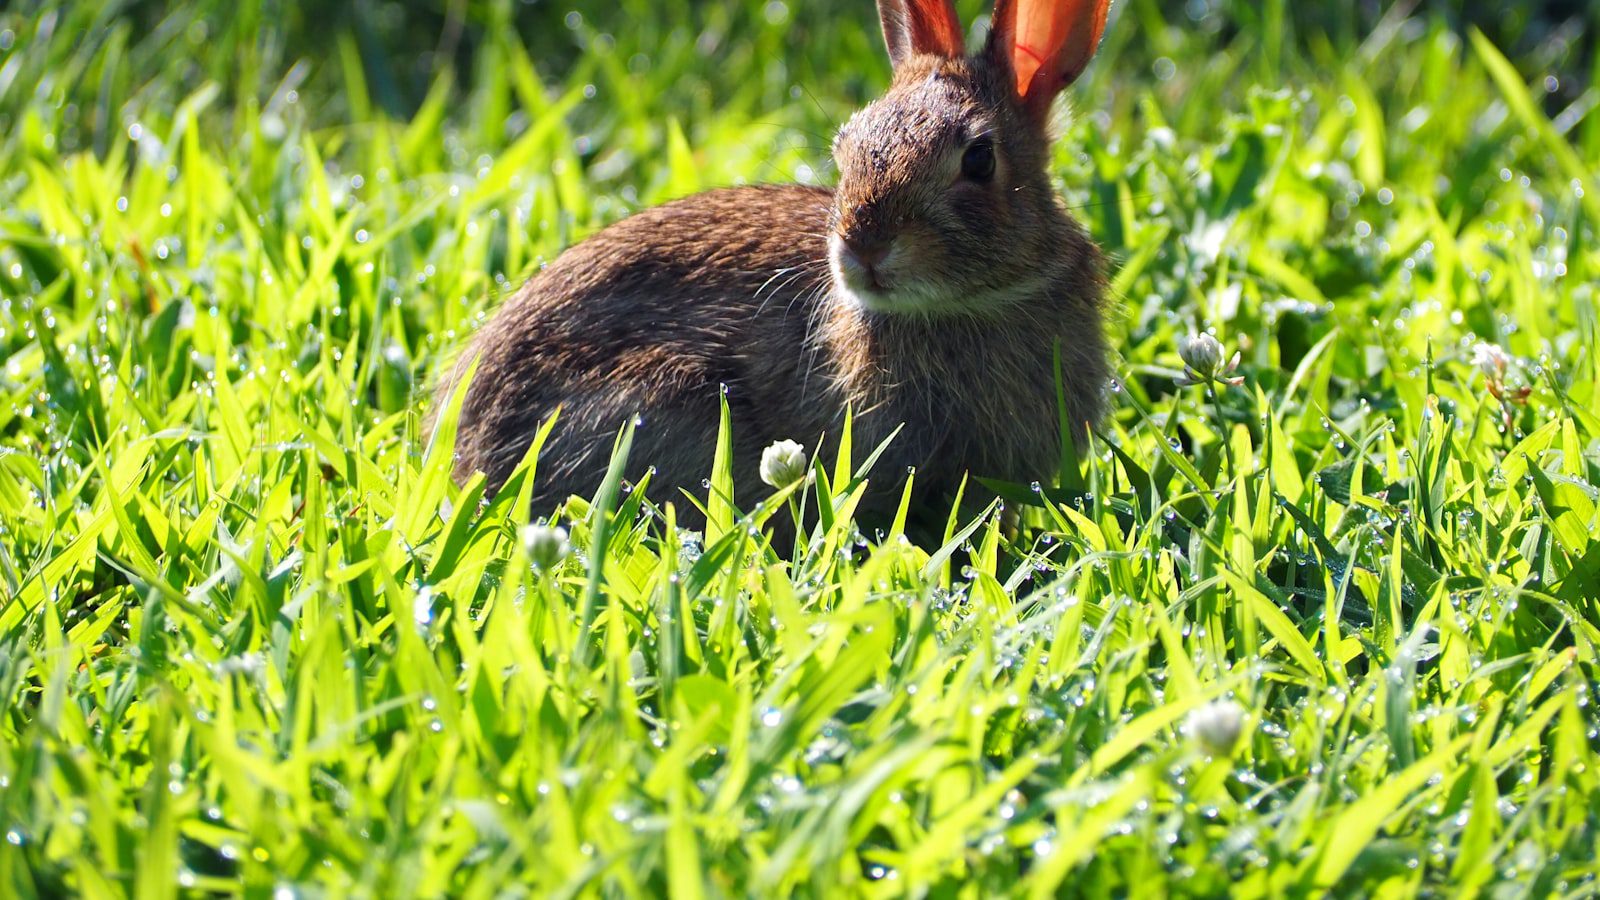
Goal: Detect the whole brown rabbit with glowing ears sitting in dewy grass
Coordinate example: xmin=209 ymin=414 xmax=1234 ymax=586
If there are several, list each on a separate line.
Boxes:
xmin=438 ymin=0 xmax=1109 ymax=522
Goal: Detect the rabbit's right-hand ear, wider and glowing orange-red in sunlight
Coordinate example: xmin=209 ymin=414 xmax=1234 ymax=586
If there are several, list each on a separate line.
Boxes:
xmin=989 ymin=0 xmax=1110 ymax=114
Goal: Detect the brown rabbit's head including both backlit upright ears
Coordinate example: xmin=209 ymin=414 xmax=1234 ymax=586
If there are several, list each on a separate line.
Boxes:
xmin=829 ymin=0 xmax=1109 ymax=317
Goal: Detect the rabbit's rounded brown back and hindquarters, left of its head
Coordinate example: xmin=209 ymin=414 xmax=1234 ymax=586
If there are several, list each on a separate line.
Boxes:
xmin=440 ymin=186 xmax=830 ymax=508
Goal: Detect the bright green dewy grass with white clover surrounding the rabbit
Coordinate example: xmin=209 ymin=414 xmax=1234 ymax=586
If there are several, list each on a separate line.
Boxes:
xmin=0 ymin=0 xmax=1600 ymax=897
